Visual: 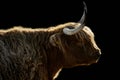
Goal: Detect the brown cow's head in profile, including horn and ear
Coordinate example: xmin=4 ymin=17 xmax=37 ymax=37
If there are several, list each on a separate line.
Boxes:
xmin=50 ymin=3 xmax=101 ymax=67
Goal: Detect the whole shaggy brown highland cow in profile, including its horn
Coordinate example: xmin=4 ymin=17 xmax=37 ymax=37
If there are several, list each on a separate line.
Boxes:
xmin=0 ymin=1 xmax=101 ymax=80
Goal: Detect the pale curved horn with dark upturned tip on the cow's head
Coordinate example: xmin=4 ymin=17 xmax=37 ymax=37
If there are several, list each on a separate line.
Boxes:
xmin=63 ymin=2 xmax=87 ymax=35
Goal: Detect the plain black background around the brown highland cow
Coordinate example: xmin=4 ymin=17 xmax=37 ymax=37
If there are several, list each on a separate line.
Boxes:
xmin=0 ymin=0 xmax=119 ymax=80
